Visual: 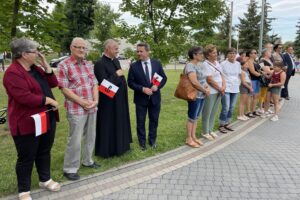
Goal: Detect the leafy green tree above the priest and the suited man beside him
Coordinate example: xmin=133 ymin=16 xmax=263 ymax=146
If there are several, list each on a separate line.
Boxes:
xmin=121 ymin=0 xmax=225 ymax=63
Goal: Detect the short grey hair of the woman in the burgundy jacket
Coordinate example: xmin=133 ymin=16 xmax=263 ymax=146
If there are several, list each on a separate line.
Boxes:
xmin=10 ymin=37 xmax=39 ymax=59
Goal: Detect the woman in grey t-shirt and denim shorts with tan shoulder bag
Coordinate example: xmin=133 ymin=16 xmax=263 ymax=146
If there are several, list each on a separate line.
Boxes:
xmin=185 ymin=47 xmax=209 ymax=148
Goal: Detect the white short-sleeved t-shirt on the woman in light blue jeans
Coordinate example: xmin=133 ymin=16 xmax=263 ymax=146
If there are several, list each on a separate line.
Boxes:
xmin=221 ymin=60 xmax=241 ymax=93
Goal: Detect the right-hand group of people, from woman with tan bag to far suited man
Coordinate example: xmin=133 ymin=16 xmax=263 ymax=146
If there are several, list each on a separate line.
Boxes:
xmin=184 ymin=44 xmax=296 ymax=148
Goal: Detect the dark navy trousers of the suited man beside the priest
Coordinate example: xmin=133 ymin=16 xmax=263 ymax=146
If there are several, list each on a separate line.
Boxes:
xmin=135 ymin=101 xmax=160 ymax=146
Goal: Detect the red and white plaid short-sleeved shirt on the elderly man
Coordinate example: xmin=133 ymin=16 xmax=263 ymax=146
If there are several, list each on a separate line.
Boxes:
xmin=57 ymin=56 xmax=98 ymax=115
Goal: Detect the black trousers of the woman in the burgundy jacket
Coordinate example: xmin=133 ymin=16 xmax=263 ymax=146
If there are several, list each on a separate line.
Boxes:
xmin=13 ymin=114 xmax=56 ymax=193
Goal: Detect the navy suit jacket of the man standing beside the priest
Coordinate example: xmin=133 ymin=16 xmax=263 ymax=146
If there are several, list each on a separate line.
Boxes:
xmin=128 ymin=59 xmax=167 ymax=106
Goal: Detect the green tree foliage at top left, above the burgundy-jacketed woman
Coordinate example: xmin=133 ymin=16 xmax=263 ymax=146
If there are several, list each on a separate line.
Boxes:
xmin=0 ymin=0 xmax=66 ymax=50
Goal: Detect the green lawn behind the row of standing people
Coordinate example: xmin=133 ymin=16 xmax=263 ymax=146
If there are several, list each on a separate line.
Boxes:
xmin=0 ymin=70 xmax=236 ymax=197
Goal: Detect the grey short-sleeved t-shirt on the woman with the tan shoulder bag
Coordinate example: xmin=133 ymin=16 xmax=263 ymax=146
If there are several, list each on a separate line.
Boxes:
xmin=185 ymin=62 xmax=206 ymax=99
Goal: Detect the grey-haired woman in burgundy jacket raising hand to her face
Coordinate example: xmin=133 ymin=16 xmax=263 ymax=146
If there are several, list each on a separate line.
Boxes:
xmin=3 ymin=38 xmax=60 ymax=200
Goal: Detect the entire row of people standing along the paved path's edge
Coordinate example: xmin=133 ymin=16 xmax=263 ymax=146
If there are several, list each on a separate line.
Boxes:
xmin=3 ymin=38 xmax=295 ymax=200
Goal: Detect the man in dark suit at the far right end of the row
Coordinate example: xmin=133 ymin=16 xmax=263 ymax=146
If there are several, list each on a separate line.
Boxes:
xmin=281 ymin=45 xmax=296 ymax=100
